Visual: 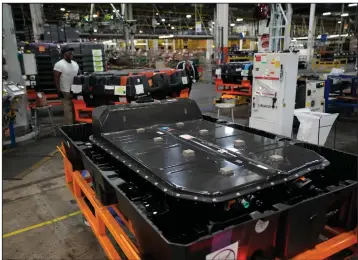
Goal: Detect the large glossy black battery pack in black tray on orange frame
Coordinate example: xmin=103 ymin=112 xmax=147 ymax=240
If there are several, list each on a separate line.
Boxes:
xmin=61 ymin=99 xmax=357 ymax=260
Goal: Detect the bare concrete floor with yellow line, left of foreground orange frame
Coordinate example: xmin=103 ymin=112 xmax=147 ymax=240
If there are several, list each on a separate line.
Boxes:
xmin=3 ymin=153 xmax=106 ymax=259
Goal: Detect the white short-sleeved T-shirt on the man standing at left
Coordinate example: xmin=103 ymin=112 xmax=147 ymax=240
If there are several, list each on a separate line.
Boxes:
xmin=53 ymin=59 xmax=79 ymax=93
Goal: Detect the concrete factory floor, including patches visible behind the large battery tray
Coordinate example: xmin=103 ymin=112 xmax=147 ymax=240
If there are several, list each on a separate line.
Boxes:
xmin=3 ymin=74 xmax=357 ymax=259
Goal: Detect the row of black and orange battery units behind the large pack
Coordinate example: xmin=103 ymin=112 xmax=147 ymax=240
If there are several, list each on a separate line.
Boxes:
xmin=71 ymin=68 xmax=190 ymax=122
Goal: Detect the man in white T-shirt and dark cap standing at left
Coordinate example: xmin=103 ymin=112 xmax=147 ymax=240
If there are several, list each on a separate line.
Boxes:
xmin=53 ymin=46 xmax=80 ymax=124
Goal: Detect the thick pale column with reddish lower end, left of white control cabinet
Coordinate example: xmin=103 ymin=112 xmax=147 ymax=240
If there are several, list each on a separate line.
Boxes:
xmin=216 ymin=4 xmax=229 ymax=62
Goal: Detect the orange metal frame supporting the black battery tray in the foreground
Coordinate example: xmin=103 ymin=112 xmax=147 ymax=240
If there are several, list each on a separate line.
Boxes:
xmin=57 ymin=140 xmax=358 ymax=260
